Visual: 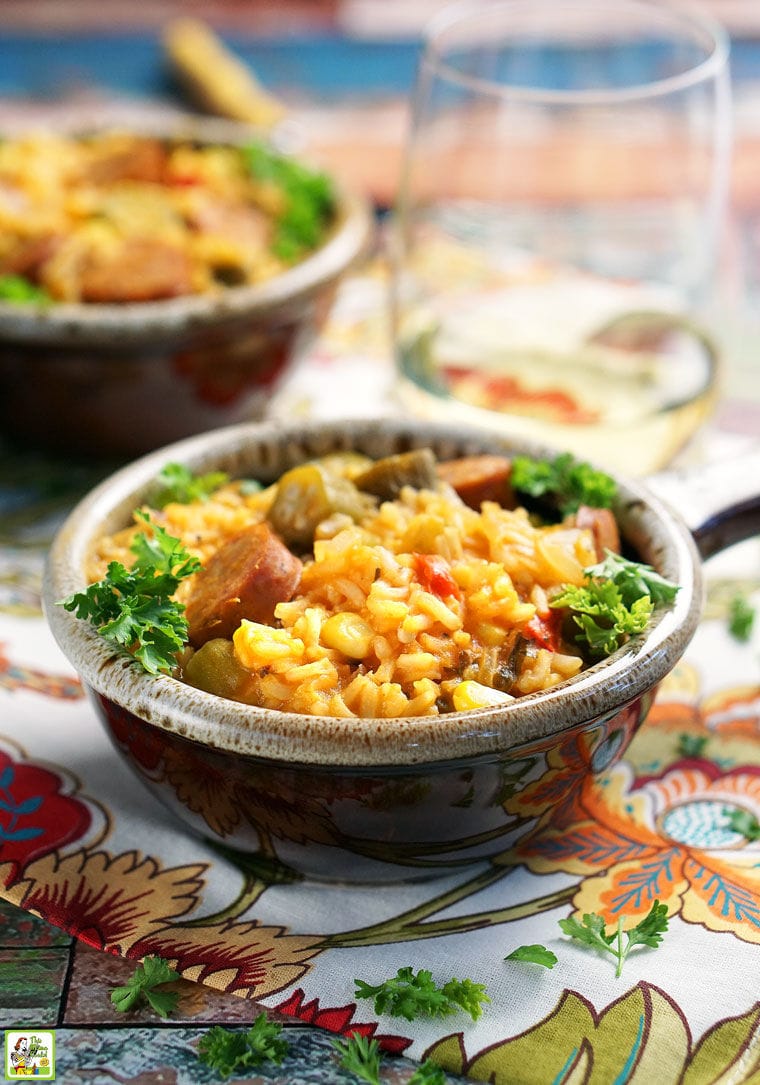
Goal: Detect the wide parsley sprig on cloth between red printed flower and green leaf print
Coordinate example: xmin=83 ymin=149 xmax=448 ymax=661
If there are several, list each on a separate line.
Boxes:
xmin=354 ymin=966 xmax=491 ymax=1021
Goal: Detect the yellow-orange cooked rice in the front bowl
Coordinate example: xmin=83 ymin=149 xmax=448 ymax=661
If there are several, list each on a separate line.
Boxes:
xmin=91 ymin=484 xmax=596 ymax=717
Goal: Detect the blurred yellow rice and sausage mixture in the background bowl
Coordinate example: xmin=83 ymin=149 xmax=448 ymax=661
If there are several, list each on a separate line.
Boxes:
xmin=0 ymin=131 xmax=317 ymax=302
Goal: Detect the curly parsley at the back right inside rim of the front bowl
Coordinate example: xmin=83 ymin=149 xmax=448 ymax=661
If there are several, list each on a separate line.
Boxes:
xmin=510 ymin=452 xmax=618 ymax=516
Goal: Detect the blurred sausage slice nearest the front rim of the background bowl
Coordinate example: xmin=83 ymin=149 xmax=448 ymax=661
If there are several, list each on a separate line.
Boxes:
xmin=80 ymin=238 xmax=193 ymax=303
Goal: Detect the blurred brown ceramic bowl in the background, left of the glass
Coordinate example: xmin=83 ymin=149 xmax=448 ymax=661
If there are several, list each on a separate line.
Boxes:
xmin=0 ymin=118 xmax=372 ymax=459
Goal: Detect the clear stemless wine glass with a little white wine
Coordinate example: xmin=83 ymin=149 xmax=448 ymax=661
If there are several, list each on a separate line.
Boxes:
xmin=390 ymin=0 xmax=731 ymax=474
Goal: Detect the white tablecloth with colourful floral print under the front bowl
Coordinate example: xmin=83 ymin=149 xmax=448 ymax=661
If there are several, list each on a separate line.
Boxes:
xmin=0 ymin=258 xmax=760 ymax=1085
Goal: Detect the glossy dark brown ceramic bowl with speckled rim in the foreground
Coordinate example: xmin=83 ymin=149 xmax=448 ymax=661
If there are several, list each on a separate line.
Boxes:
xmin=45 ymin=420 xmax=760 ymax=881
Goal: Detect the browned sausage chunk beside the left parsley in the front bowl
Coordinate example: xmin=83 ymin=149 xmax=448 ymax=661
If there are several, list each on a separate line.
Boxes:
xmin=186 ymin=523 xmax=302 ymax=648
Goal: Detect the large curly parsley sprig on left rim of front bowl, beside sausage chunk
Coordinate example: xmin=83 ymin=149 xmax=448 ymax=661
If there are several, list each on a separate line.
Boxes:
xmin=61 ymin=512 xmax=201 ymax=675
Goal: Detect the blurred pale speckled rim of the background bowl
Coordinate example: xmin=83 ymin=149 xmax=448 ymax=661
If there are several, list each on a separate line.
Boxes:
xmin=0 ymin=116 xmax=373 ymax=344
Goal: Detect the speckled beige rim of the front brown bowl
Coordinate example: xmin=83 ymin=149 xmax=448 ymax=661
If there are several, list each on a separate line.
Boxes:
xmin=43 ymin=419 xmax=704 ymax=768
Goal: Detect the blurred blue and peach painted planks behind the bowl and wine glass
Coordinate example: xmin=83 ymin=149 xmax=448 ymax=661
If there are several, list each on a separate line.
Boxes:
xmin=0 ymin=0 xmax=760 ymax=432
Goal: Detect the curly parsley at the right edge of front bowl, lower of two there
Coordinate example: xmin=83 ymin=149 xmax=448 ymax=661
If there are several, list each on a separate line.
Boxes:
xmin=549 ymin=550 xmax=679 ymax=658
